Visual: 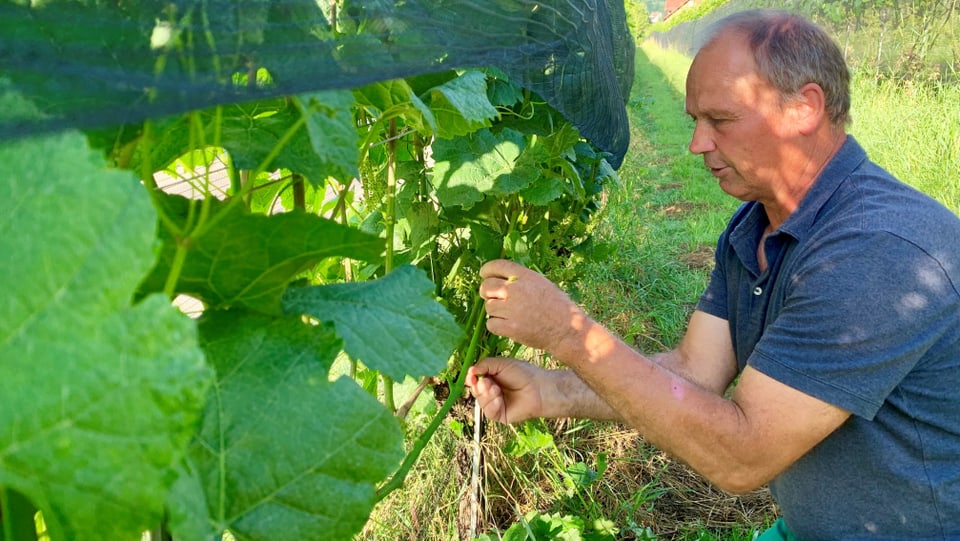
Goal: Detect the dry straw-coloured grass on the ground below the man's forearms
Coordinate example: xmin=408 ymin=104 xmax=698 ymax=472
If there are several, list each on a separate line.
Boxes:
xmin=359 ymin=392 xmax=776 ymax=541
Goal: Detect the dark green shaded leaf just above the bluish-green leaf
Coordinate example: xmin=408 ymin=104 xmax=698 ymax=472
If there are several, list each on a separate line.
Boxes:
xmin=141 ymin=196 xmax=383 ymax=314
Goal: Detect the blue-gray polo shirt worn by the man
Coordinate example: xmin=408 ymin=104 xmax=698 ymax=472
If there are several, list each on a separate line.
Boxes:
xmin=697 ymin=137 xmax=960 ymax=541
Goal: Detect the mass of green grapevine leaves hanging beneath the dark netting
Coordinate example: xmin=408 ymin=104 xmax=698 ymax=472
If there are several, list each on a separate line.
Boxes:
xmin=0 ymin=2 xmax=617 ymax=541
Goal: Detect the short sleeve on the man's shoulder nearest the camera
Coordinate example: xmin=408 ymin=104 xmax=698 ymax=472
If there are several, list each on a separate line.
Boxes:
xmin=748 ymin=228 xmax=957 ymax=419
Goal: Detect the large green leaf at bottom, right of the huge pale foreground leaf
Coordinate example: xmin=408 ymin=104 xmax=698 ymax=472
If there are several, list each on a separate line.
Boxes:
xmin=170 ymin=310 xmax=403 ymax=541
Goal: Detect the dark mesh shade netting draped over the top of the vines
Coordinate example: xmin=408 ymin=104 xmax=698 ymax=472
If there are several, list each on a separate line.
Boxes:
xmin=0 ymin=0 xmax=634 ymax=167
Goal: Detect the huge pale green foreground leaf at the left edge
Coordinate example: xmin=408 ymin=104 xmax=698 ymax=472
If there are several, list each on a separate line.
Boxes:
xmin=0 ymin=134 xmax=210 ymax=540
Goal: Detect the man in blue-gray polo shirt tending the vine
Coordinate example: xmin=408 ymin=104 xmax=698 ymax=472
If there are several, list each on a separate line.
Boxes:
xmin=468 ymin=11 xmax=960 ymax=541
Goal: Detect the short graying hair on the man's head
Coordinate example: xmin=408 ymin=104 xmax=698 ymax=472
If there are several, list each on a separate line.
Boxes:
xmin=704 ymin=9 xmax=850 ymax=129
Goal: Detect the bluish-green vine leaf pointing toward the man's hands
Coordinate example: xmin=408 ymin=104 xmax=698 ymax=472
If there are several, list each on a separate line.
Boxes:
xmin=282 ymin=265 xmax=462 ymax=381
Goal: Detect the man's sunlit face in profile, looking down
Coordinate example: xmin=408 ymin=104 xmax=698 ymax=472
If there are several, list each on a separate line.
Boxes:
xmin=686 ymin=32 xmax=795 ymax=202
